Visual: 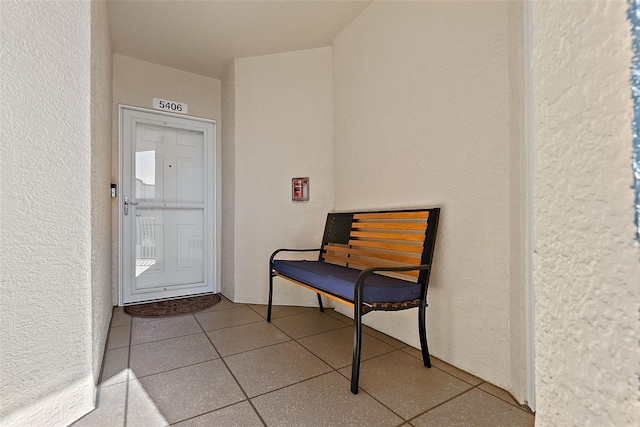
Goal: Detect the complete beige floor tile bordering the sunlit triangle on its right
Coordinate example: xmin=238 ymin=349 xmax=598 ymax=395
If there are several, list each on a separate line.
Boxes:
xmin=140 ymin=359 xmax=245 ymax=423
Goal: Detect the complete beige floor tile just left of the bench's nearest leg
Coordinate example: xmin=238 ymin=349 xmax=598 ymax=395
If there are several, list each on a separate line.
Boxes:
xmin=224 ymin=341 xmax=331 ymax=397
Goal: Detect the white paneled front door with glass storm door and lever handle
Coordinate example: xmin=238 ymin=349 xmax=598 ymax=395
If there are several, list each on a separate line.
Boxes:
xmin=118 ymin=107 xmax=216 ymax=304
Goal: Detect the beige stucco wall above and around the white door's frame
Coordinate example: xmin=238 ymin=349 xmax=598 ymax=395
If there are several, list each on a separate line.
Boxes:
xmin=111 ymin=54 xmax=222 ymax=303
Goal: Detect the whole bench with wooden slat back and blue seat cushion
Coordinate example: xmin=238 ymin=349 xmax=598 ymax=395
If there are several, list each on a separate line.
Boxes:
xmin=267 ymin=208 xmax=440 ymax=394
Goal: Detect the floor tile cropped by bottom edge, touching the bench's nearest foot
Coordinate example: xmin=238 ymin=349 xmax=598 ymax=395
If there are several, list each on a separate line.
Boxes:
xmin=253 ymin=372 xmax=402 ymax=427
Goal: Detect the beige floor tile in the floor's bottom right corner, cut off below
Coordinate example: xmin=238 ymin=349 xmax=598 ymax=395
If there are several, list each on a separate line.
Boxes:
xmin=411 ymin=389 xmax=534 ymax=427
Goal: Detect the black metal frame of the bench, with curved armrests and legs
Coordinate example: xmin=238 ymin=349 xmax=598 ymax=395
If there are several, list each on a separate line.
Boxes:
xmin=267 ymin=208 xmax=440 ymax=394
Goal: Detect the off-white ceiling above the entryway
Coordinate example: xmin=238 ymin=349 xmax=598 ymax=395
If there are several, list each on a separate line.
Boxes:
xmin=108 ymin=0 xmax=371 ymax=79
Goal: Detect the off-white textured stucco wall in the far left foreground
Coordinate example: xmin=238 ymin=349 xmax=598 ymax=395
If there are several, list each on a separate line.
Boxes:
xmin=0 ymin=2 xmax=94 ymax=426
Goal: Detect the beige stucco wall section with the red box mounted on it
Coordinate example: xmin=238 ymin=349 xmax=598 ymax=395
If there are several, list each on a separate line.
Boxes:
xmin=235 ymin=47 xmax=333 ymax=305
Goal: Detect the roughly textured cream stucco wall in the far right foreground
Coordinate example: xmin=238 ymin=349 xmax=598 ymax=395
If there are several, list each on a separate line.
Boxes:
xmin=533 ymin=2 xmax=640 ymax=426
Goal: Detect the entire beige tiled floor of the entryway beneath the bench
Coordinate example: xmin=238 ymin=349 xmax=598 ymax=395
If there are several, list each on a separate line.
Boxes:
xmin=74 ymin=298 xmax=534 ymax=427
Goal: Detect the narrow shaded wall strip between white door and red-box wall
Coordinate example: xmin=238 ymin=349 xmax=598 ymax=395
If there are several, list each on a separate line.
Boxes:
xmin=221 ymin=61 xmax=236 ymax=301
